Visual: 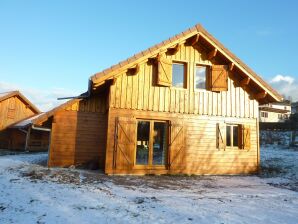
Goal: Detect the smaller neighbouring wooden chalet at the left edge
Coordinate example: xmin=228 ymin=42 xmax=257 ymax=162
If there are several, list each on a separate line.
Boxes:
xmin=0 ymin=91 xmax=49 ymax=151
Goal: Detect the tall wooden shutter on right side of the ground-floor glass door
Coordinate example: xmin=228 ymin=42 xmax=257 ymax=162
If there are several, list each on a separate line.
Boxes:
xmin=168 ymin=121 xmax=186 ymax=170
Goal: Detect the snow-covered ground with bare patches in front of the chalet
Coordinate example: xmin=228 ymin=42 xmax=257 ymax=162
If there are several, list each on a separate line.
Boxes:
xmin=0 ymin=148 xmax=298 ymax=224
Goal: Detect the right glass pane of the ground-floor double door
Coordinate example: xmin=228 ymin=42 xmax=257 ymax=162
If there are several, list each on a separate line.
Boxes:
xmin=152 ymin=122 xmax=168 ymax=165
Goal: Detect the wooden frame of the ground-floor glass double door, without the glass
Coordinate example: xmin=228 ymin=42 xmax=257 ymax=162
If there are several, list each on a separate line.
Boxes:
xmin=133 ymin=118 xmax=170 ymax=169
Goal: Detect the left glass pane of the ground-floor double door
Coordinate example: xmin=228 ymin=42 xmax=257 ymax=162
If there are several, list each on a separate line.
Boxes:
xmin=136 ymin=121 xmax=150 ymax=165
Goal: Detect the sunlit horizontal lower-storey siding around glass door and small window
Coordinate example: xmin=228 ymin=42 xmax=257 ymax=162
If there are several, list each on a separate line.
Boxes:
xmin=105 ymin=109 xmax=259 ymax=174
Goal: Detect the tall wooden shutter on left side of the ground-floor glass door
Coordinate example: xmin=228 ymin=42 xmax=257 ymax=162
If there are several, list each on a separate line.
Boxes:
xmin=113 ymin=117 xmax=136 ymax=170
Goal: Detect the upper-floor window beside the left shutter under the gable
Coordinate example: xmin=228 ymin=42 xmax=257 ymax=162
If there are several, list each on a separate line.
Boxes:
xmin=172 ymin=62 xmax=186 ymax=88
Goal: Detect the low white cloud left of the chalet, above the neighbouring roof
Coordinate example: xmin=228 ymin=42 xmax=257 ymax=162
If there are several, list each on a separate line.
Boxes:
xmin=0 ymin=82 xmax=81 ymax=111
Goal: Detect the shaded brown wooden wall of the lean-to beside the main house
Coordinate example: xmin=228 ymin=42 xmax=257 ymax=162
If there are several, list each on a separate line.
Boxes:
xmin=48 ymin=95 xmax=107 ymax=168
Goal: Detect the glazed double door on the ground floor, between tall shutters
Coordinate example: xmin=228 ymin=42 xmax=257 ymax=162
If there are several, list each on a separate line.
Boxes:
xmin=135 ymin=120 xmax=168 ymax=165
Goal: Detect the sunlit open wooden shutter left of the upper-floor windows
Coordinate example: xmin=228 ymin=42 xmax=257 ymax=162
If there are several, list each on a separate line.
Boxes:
xmin=157 ymin=57 xmax=172 ymax=86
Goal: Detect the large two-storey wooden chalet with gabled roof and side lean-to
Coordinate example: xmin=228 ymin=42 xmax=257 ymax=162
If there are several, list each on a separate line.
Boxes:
xmin=33 ymin=25 xmax=282 ymax=174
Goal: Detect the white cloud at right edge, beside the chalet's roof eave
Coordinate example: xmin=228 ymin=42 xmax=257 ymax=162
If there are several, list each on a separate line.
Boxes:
xmin=270 ymin=75 xmax=298 ymax=101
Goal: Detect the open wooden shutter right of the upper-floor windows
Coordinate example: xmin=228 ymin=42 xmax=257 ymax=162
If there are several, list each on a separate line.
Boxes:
xmin=208 ymin=65 xmax=228 ymax=91
